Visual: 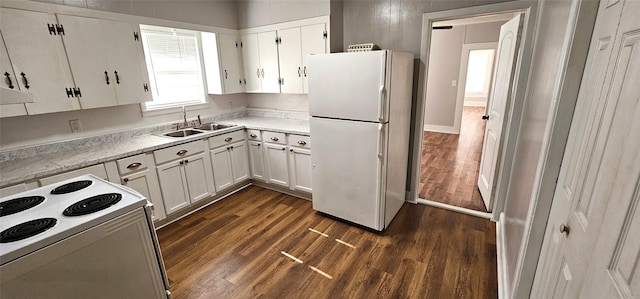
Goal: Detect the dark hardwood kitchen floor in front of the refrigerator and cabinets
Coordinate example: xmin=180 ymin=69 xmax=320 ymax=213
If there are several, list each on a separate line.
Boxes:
xmin=158 ymin=186 xmax=497 ymax=299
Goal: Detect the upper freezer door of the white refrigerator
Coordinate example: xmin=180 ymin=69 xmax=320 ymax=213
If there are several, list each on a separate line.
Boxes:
xmin=308 ymin=51 xmax=388 ymax=122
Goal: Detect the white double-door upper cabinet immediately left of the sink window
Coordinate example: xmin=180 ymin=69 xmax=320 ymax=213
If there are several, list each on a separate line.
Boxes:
xmin=58 ymin=15 xmax=151 ymax=109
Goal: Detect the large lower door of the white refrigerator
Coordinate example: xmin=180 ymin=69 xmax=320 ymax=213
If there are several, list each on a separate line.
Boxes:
xmin=311 ymin=117 xmax=387 ymax=230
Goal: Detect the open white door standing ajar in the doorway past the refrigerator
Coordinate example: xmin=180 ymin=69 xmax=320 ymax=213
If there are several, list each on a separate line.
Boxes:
xmin=478 ymin=15 xmax=522 ymax=211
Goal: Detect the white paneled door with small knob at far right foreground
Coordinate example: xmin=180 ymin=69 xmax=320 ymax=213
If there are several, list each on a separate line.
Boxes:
xmin=532 ymin=1 xmax=640 ymax=298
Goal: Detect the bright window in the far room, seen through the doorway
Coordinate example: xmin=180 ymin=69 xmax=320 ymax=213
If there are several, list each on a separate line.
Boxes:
xmin=464 ymin=49 xmax=494 ymax=95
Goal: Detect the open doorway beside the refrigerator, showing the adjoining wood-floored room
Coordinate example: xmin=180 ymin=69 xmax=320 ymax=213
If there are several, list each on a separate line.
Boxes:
xmin=418 ymin=12 xmax=514 ymax=218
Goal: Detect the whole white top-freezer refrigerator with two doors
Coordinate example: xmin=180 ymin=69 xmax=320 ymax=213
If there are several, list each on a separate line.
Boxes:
xmin=308 ymin=50 xmax=413 ymax=231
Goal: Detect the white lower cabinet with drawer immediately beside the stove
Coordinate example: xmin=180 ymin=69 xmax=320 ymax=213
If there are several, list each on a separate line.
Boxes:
xmin=116 ymin=154 xmax=166 ymax=221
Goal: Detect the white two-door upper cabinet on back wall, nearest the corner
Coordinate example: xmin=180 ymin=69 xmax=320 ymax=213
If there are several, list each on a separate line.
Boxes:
xmin=241 ymin=31 xmax=280 ymax=93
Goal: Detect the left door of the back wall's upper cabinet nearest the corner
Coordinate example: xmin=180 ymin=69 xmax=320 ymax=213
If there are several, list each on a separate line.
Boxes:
xmin=240 ymin=33 xmax=262 ymax=92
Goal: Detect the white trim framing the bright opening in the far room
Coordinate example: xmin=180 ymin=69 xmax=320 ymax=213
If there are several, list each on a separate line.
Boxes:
xmin=453 ymin=42 xmax=499 ymax=134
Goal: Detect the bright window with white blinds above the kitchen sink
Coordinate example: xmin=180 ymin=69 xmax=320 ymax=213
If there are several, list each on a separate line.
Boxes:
xmin=140 ymin=25 xmax=205 ymax=110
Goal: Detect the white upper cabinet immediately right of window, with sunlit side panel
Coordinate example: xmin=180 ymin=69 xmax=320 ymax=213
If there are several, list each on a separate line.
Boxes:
xmin=201 ymin=32 xmax=245 ymax=94
